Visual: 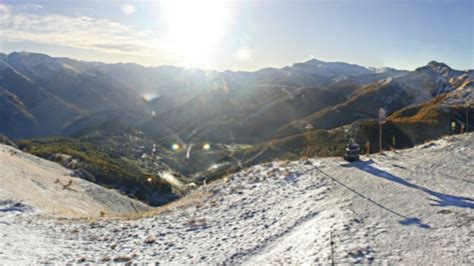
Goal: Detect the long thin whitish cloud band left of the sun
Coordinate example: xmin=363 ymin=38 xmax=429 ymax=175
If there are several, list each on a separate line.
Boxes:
xmin=0 ymin=4 xmax=172 ymax=56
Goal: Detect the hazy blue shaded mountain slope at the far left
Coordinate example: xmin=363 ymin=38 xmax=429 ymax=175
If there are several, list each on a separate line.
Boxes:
xmin=0 ymin=52 xmax=149 ymax=138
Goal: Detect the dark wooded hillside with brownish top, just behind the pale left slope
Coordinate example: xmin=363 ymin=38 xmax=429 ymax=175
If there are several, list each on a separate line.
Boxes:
xmin=17 ymin=136 xmax=178 ymax=206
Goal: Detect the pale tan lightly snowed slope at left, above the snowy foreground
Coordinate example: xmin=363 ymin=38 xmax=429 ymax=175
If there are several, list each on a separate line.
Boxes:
xmin=0 ymin=144 xmax=150 ymax=218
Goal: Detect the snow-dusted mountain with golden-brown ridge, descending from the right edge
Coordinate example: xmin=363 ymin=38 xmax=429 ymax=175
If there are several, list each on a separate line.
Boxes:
xmin=278 ymin=61 xmax=474 ymax=136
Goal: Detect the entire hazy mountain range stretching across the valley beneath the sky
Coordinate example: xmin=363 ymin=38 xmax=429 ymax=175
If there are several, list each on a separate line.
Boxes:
xmin=0 ymin=52 xmax=473 ymax=143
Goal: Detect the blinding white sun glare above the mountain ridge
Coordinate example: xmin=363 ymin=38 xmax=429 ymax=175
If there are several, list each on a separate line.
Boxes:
xmin=161 ymin=0 xmax=231 ymax=67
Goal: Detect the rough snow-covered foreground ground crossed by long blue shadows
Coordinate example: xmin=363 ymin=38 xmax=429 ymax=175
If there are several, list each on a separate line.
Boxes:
xmin=0 ymin=134 xmax=474 ymax=265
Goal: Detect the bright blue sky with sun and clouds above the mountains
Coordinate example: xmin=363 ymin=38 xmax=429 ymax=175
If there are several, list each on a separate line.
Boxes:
xmin=0 ymin=0 xmax=474 ymax=71
